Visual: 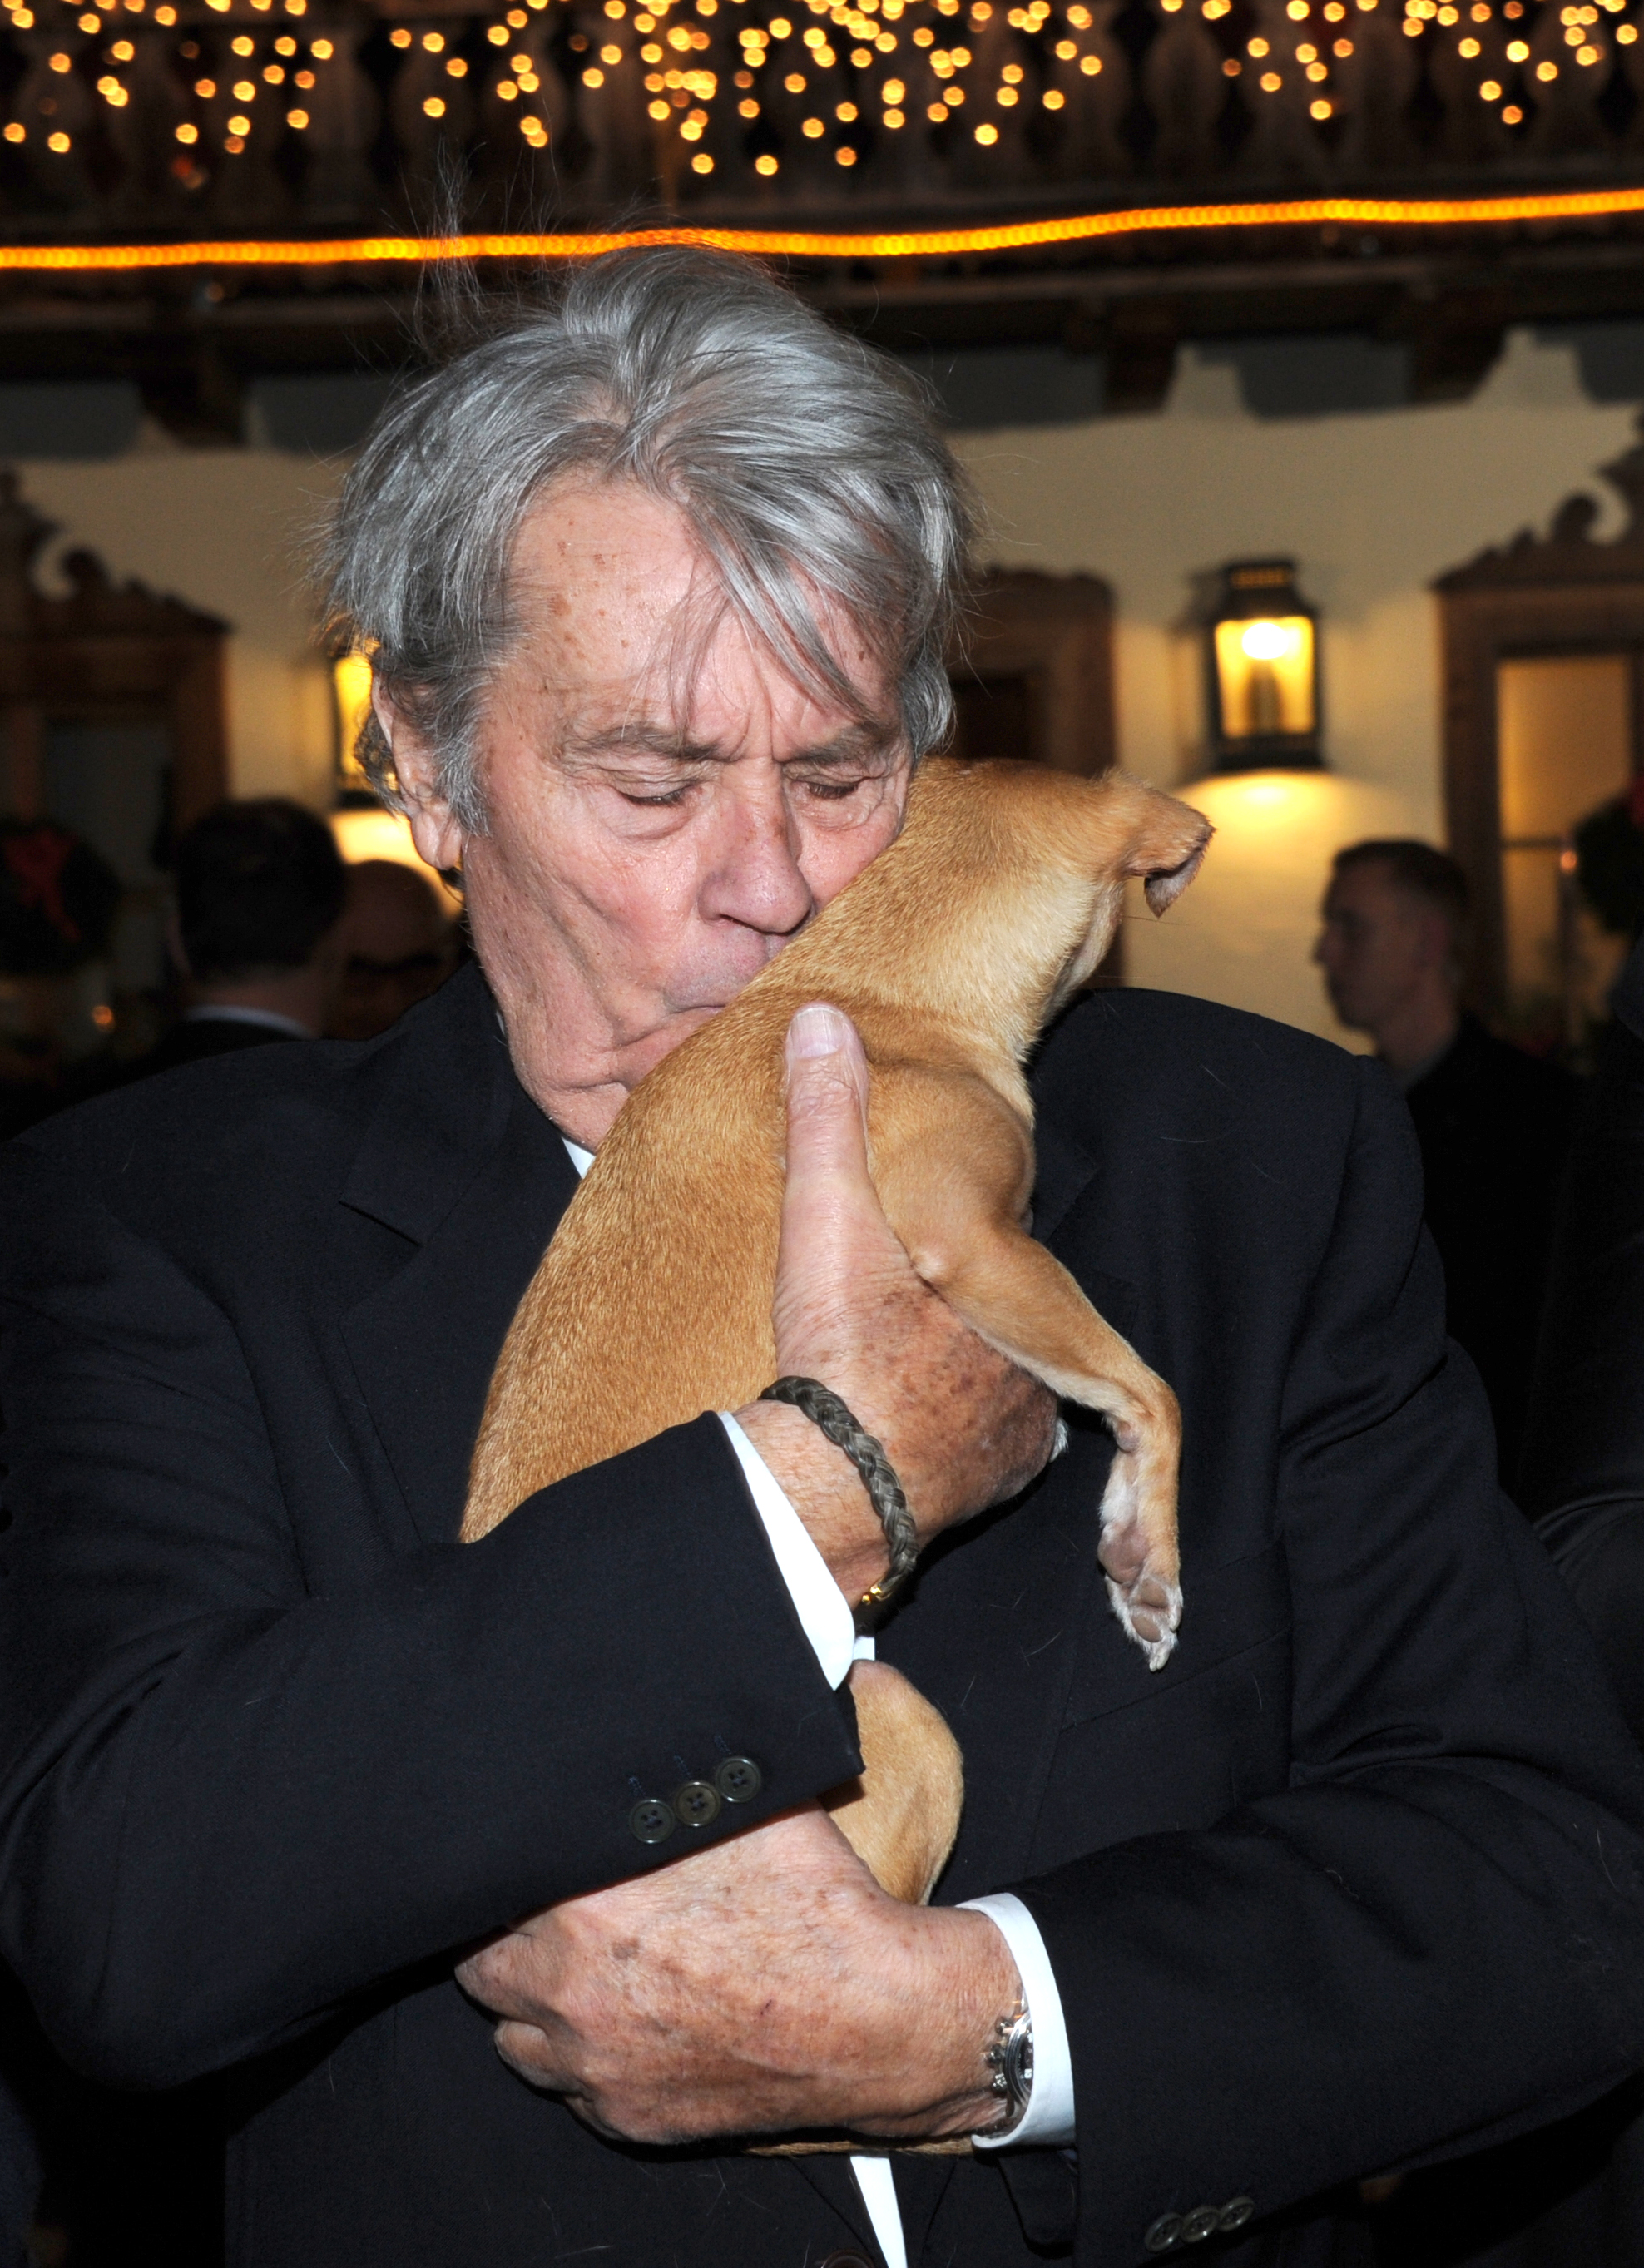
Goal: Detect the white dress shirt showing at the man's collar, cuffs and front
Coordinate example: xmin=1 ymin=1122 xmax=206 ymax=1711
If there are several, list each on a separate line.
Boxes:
xmin=560 ymin=1136 xmax=1075 ymax=2268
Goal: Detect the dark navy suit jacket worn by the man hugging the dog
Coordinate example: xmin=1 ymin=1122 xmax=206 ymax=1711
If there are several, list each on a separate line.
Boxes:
xmin=0 ymin=973 xmax=1644 ymax=2268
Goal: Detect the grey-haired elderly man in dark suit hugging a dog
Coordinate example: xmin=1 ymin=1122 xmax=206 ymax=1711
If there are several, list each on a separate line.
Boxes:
xmin=0 ymin=254 xmax=1644 ymax=2268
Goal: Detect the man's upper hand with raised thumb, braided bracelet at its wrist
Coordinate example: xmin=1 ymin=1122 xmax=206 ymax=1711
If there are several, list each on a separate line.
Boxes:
xmin=737 ymin=1005 xmax=1057 ymax=1603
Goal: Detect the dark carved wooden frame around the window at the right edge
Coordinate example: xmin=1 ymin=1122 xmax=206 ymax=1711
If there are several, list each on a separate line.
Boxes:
xmin=1434 ymin=418 xmax=1644 ymax=1014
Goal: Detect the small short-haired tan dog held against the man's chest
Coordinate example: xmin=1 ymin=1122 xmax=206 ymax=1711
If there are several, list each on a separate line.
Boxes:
xmin=463 ymin=760 xmax=1211 ymax=1900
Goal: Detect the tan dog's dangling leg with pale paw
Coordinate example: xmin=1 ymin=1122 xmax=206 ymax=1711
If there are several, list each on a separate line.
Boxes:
xmin=875 ymin=1071 xmax=1181 ymax=1669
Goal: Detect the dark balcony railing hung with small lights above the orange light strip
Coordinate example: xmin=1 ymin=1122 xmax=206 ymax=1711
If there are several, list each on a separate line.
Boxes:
xmin=0 ymin=0 xmax=1644 ymax=243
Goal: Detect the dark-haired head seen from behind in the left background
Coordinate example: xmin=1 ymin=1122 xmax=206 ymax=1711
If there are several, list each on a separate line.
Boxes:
xmin=136 ymin=796 xmax=347 ymax=1075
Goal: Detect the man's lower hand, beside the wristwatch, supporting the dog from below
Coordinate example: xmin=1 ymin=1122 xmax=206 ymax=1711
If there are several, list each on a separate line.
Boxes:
xmin=458 ymin=1805 xmax=1020 ymax=2143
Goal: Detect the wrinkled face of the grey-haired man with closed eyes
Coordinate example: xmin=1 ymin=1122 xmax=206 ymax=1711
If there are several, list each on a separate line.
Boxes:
xmin=390 ymin=483 xmax=909 ymax=1141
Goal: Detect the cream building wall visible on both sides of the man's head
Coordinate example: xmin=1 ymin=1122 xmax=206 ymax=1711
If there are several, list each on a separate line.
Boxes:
xmin=21 ymin=334 xmax=1632 ymax=1039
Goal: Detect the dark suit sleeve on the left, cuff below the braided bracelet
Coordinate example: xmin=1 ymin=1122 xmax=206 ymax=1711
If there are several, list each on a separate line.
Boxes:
xmin=0 ymin=1150 xmax=859 ymax=2087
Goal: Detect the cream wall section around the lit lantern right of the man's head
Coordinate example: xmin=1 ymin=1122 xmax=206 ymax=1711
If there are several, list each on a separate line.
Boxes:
xmin=959 ymin=334 xmax=1632 ymax=1039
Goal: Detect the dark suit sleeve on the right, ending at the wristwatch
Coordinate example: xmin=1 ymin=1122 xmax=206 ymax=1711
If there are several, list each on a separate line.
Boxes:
xmin=1016 ymin=1072 xmax=1644 ymax=2268
